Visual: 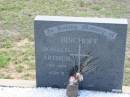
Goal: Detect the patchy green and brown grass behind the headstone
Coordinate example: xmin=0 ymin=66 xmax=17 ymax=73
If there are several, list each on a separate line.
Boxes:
xmin=0 ymin=0 xmax=130 ymax=85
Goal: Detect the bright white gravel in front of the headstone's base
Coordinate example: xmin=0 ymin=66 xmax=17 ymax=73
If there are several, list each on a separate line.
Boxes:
xmin=0 ymin=87 xmax=130 ymax=97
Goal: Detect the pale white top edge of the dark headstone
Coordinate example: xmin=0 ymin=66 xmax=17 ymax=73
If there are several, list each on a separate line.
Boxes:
xmin=35 ymin=15 xmax=128 ymax=24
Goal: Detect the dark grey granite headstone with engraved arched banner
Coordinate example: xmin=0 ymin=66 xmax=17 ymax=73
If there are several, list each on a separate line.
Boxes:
xmin=34 ymin=16 xmax=127 ymax=91
